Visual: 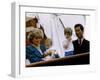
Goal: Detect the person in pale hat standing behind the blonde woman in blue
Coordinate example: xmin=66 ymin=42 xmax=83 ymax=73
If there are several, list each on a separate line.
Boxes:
xmin=26 ymin=16 xmax=47 ymax=45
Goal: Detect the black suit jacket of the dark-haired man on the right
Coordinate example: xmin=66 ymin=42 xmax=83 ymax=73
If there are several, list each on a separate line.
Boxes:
xmin=73 ymin=39 xmax=90 ymax=54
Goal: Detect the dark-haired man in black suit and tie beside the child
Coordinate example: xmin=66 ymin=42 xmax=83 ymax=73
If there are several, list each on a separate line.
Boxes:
xmin=73 ymin=24 xmax=89 ymax=54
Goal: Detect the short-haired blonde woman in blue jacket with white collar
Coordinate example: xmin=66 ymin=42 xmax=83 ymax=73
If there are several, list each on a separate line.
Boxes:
xmin=26 ymin=28 xmax=51 ymax=63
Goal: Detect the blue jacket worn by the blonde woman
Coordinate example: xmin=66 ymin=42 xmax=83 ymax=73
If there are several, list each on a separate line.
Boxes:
xmin=26 ymin=45 xmax=46 ymax=63
